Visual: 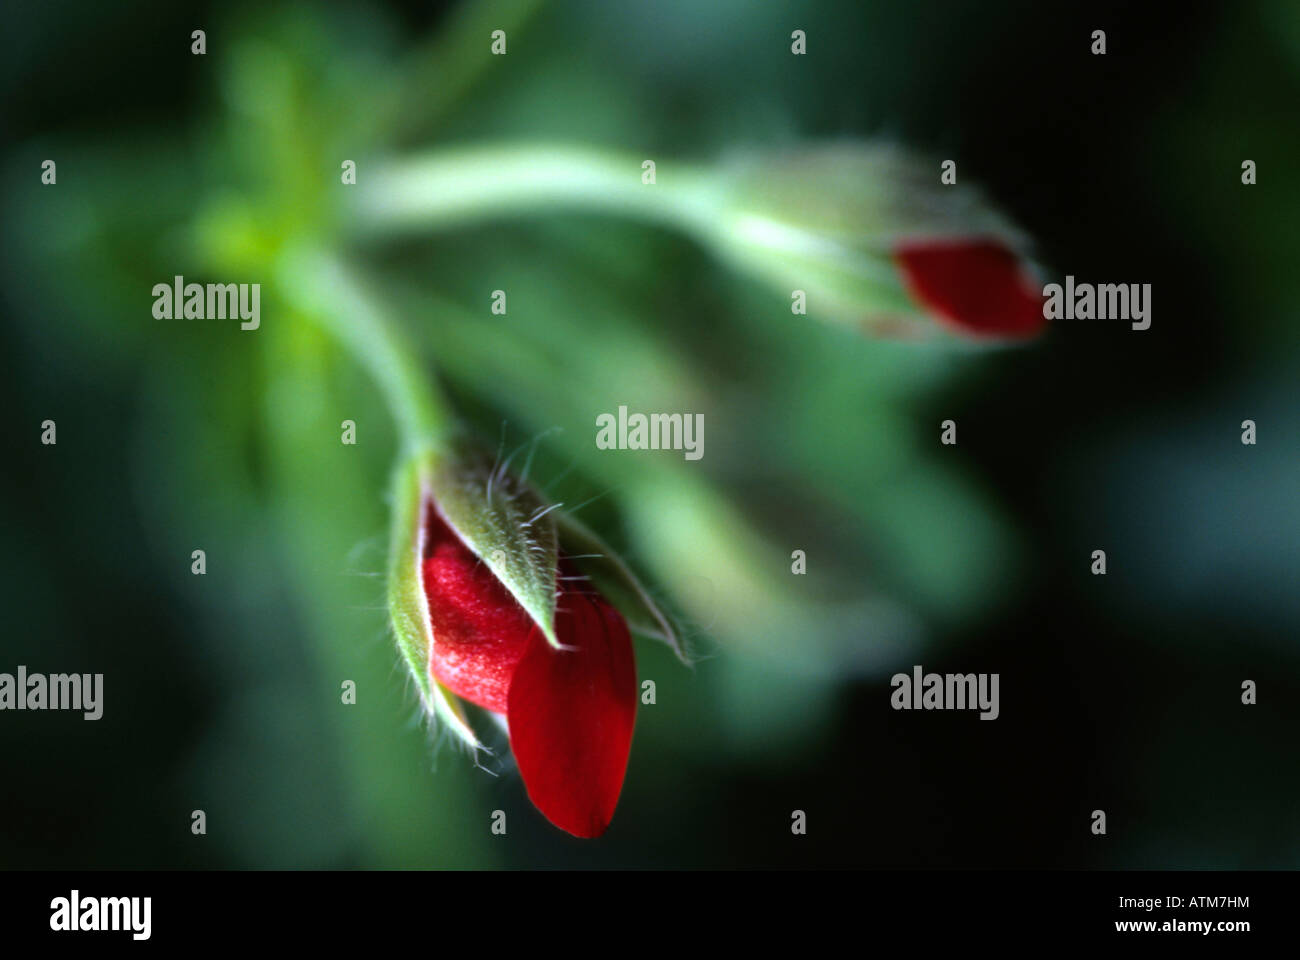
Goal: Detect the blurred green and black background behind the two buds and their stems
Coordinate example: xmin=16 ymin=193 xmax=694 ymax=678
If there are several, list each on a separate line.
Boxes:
xmin=0 ymin=0 xmax=1300 ymax=868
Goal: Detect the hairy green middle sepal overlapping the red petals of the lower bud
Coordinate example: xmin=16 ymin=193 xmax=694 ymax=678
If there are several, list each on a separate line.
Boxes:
xmin=430 ymin=451 xmax=560 ymax=648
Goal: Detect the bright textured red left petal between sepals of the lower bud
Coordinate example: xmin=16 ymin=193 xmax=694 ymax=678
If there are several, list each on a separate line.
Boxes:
xmin=424 ymin=511 xmax=533 ymax=713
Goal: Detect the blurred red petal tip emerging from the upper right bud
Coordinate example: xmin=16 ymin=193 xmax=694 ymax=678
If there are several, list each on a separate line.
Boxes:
xmin=894 ymin=241 xmax=1047 ymax=337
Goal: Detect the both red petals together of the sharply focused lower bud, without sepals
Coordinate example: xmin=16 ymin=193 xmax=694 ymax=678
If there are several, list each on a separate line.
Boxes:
xmin=423 ymin=506 xmax=637 ymax=838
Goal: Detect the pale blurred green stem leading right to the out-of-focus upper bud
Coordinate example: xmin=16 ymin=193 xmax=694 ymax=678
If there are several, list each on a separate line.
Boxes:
xmin=355 ymin=144 xmax=718 ymax=234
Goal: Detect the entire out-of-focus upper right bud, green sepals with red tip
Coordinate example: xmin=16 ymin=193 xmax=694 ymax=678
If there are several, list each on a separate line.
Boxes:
xmin=705 ymin=143 xmax=1044 ymax=338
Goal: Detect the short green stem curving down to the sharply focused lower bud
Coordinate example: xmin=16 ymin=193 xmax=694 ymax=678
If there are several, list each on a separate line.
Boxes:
xmin=278 ymin=246 xmax=451 ymax=453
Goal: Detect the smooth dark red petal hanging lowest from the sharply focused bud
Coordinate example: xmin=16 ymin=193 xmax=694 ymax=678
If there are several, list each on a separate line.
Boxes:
xmin=507 ymin=580 xmax=637 ymax=838
